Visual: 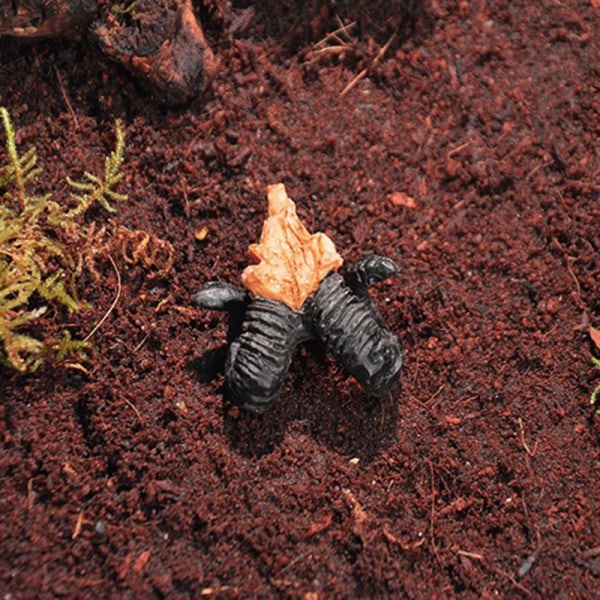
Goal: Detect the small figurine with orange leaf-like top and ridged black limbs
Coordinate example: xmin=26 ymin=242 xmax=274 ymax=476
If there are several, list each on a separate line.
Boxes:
xmin=194 ymin=183 xmax=403 ymax=413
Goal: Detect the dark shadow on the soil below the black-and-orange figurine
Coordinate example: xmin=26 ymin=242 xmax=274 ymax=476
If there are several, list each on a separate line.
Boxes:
xmin=191 ymin=343 xmax=399 ymax=461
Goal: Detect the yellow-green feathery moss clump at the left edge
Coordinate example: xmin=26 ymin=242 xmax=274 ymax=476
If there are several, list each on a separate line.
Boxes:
xmin=0 ymin=107 xmax=126 ymax=372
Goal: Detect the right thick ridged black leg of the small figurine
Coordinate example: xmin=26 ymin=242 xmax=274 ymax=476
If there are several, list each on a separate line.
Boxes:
xmin=310 ymin=273 xmax=402 ymax=396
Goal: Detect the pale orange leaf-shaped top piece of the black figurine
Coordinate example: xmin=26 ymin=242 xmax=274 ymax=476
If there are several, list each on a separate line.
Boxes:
xmin=242 ymin=183 xmax=342 ymax=311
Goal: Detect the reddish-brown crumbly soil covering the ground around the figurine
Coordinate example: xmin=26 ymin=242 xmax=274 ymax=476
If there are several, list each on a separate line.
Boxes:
xmin=0 ymin=0 xmax=600 ymax=600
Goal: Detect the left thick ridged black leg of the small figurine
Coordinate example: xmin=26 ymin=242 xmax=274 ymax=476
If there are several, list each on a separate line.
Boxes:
xmin=225 ymin=298 xmax=307 ymax=413
